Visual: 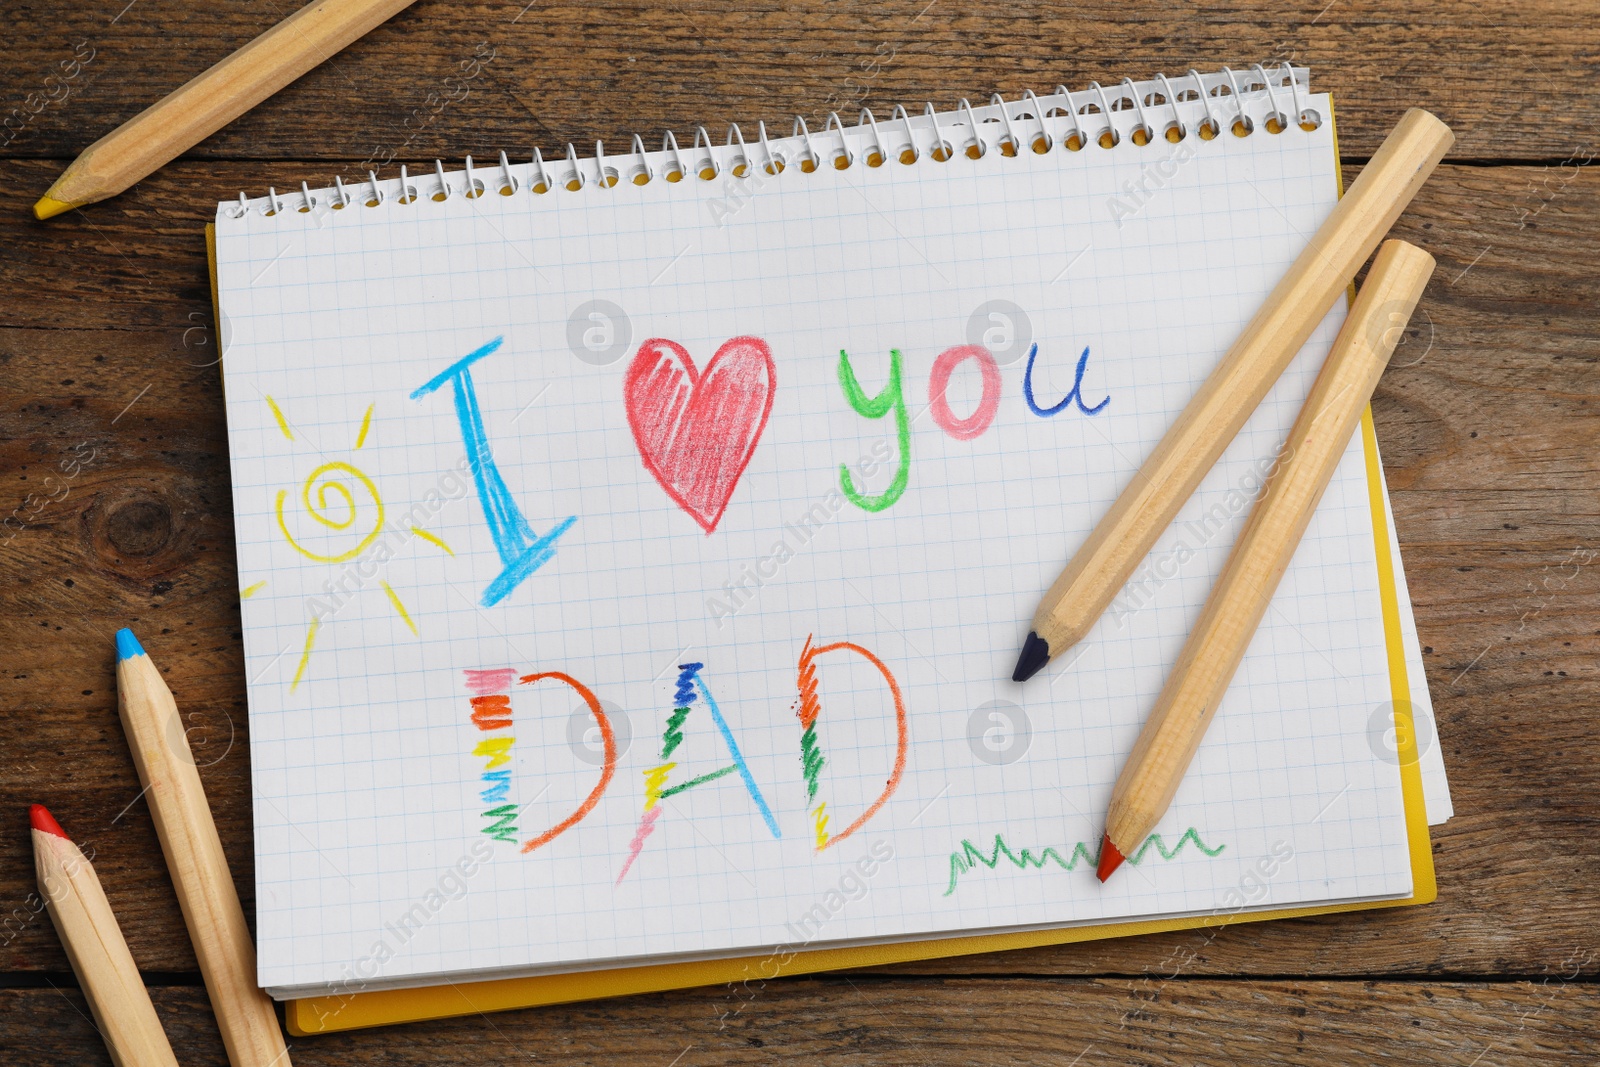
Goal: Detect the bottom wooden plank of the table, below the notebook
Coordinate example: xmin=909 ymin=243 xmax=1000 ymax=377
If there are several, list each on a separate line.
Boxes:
xmin=0 ymin=974 xmax=1600 ymax=1067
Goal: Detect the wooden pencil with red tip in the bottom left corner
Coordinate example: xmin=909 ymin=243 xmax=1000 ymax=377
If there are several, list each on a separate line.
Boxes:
xmin=27 ymin=805 xmax=178 ymax=1067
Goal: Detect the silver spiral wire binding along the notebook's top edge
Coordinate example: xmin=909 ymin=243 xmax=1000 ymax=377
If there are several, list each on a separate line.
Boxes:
xmin=228 ymin=62 xmax=1323 ymax=219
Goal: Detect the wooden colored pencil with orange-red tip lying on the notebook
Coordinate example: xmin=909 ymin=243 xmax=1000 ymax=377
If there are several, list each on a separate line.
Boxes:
xmin=1098 ymin=242 xmax=1434 ymax=881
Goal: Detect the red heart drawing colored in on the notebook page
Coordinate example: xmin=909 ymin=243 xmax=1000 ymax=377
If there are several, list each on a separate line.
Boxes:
xmin=624 ymin=338 xmax=778 ymax=534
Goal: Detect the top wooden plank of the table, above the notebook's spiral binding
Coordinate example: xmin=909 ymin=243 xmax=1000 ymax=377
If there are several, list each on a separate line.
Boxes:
xmin=0 ymin=0 xmax=1600 ymax=167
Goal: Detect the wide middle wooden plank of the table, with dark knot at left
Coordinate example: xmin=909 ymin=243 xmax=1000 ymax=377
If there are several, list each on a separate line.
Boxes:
xmin=0 ymin=162 xmax=1600 ymax=976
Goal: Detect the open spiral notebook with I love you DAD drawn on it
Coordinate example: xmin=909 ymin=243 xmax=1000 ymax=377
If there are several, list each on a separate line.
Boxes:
xmin=203 ymin=67 xmax=1448 ymax=1032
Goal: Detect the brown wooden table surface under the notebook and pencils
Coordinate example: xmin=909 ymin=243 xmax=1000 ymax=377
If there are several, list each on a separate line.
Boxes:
xmin=0 ymin=0 xmax=1600 ymax=1067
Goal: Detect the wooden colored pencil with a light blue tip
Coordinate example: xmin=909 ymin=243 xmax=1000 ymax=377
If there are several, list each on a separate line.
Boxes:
xmin=117 ymin=630 xmax=288 ymax=1067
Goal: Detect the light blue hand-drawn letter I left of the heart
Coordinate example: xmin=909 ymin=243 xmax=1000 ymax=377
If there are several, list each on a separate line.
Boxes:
xmin=411 ymin=338 xmax=578 ymax=608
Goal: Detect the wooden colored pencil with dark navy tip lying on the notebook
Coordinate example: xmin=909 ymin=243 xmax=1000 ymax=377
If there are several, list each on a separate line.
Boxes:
xmin=1011 ymin=109 xmax=1454 ymax=681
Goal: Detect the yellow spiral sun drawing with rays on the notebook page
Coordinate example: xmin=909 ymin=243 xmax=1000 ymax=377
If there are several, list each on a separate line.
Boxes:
xmin=238 ymin=397 xmax=456 ymax=693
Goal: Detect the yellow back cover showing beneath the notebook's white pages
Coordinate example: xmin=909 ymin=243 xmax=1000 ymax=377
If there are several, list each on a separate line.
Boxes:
xmin=206 ymin=95 xmax=1437 ymax=1037
